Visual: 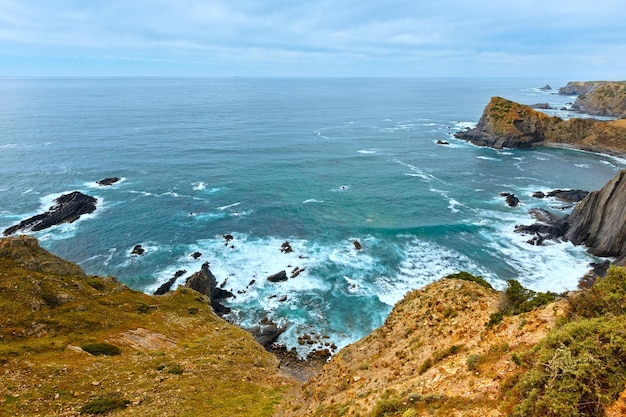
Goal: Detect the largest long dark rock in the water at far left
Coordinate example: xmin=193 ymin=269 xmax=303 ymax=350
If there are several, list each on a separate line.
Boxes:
xmin=4 ymin=191 xmax=98 ymax=236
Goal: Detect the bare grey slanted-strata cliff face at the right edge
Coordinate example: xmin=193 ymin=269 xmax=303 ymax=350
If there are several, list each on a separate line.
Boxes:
xmin=565 ymin=170 xmax=626 ymax=263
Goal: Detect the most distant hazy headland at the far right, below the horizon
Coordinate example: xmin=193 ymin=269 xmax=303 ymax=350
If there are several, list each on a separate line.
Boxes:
xmin=559 ymin=81 xmax=626 ymax=118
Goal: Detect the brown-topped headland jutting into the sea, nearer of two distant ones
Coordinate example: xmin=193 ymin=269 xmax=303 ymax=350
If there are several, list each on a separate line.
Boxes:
xmin=455 ymin=97 xmax=626 ymax=154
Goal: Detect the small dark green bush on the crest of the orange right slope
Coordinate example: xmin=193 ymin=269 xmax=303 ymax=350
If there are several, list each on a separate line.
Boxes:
xmin=487 ymin=279 xmax=557 ymax=327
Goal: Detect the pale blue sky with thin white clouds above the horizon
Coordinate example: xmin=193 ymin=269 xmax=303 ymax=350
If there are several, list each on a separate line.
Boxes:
xmin=0 ymin=0 xmax=626 ymax=80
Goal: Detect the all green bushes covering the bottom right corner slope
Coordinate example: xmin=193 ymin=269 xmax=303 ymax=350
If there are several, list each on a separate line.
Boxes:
xmin=504 ymin=267 xmax=626 ymax=417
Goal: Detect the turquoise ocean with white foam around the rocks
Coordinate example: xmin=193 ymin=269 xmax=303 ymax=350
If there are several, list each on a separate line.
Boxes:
xmin=0 ymin=77 xmax=625 ymax=354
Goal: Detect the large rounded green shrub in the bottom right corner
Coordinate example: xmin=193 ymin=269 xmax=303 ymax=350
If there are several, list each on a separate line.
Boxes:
xmin=511 ymin=316 xmax=626 ymax=417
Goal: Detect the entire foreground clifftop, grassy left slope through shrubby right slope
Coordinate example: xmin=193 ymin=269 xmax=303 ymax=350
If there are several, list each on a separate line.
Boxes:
xmin=0 ymin=236 xmax=626 ymax=417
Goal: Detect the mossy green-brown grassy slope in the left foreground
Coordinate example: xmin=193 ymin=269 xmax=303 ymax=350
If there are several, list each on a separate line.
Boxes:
xmin=0 ymin=236 xmax=296 ymax=416
